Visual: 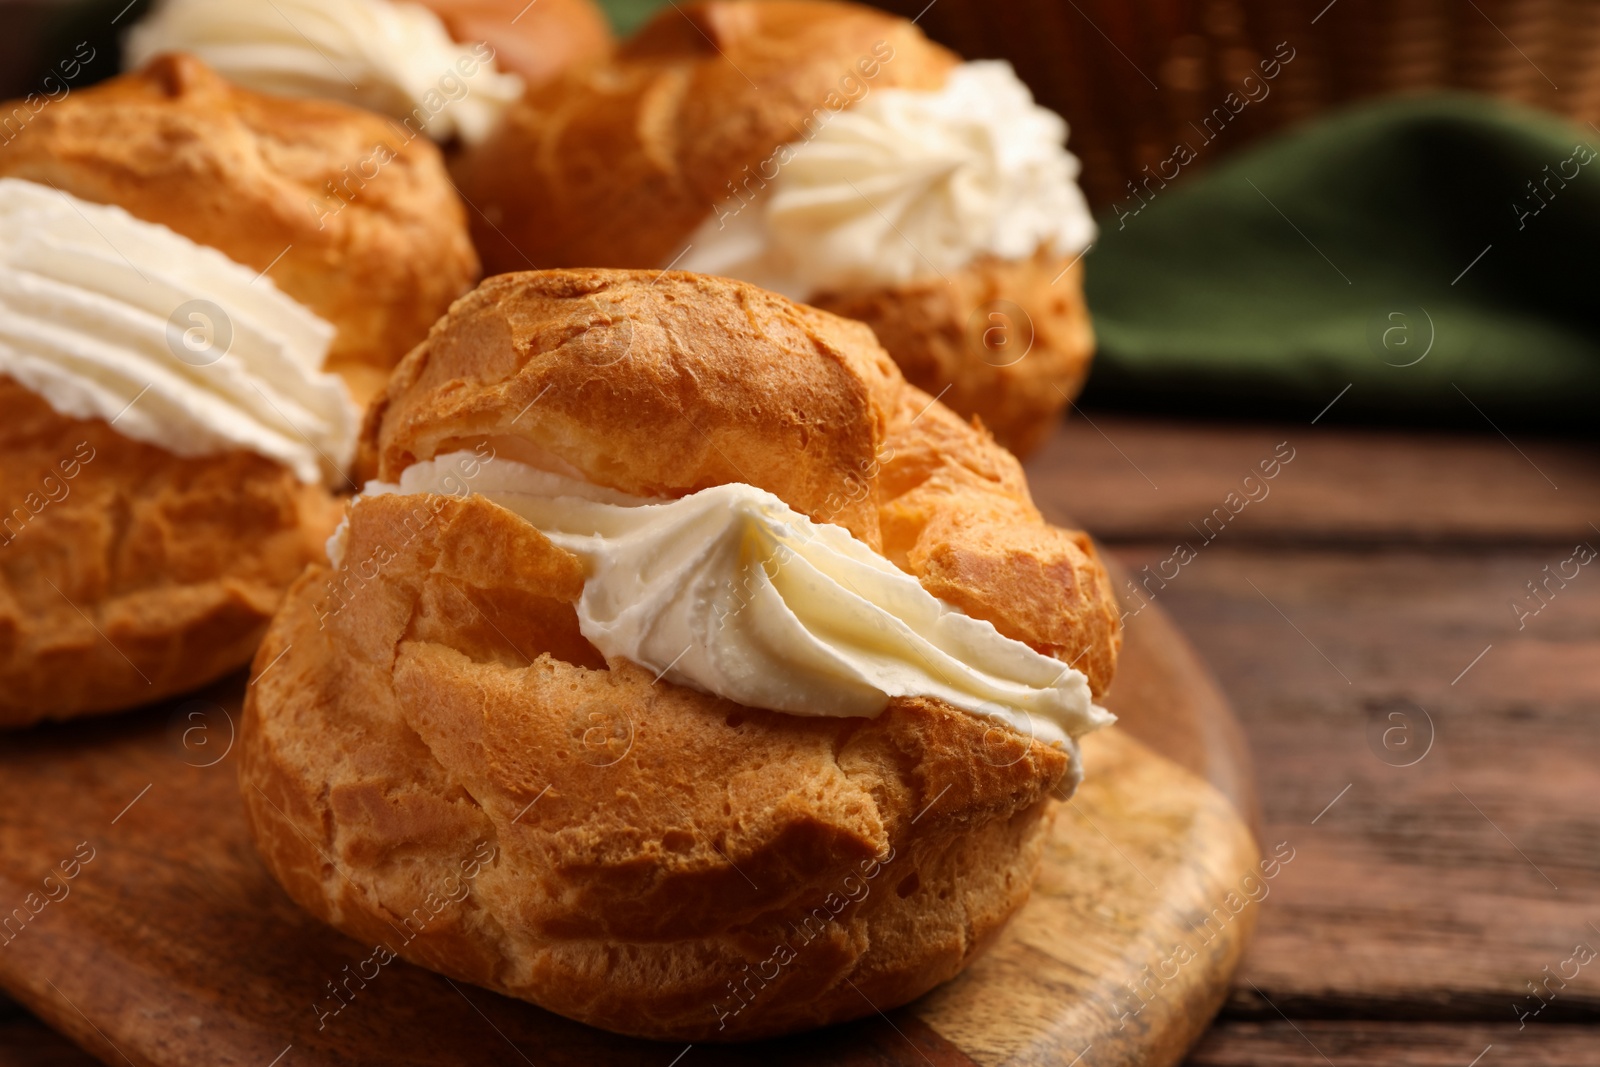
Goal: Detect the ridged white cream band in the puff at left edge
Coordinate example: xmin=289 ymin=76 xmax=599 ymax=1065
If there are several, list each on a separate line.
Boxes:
xmin=0 ymin=178 xmax=360 ymax=483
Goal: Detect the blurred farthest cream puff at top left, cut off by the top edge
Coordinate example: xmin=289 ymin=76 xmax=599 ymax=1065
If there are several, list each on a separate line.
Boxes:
xmin=125 ymin=0 xmax=611 ymax=142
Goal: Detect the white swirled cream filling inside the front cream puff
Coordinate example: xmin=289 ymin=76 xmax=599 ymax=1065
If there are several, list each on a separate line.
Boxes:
xmin=337 ymin=453 xmax=1114 ymax=751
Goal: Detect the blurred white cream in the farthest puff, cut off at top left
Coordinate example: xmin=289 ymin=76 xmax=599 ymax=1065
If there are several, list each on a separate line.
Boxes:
xmin=126 ymin=0 xmax=522 ymax=142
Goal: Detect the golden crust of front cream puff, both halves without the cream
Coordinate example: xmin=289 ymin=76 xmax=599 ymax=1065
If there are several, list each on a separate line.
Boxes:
xmin=240 ymin=270 xmax=1120 ymax=1041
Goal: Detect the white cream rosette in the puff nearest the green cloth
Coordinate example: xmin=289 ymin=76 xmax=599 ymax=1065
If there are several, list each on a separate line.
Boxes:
xmin=677 ymin=61 xmax=1096 ymax=301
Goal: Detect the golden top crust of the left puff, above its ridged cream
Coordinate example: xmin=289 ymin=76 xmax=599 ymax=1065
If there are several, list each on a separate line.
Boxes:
xmin=0 ymin=54 xmax=478 ymax=403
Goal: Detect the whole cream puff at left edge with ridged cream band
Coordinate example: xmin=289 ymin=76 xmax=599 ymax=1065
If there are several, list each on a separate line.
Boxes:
xmin=0 ymin=56 xmax=477 ymax=726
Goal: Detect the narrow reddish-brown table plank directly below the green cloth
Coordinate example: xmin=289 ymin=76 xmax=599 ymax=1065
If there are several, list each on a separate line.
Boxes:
xmin=1029 ymin=411 xmax=1600 ymax=549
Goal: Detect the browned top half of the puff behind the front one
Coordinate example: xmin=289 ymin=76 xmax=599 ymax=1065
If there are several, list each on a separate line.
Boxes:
xmin=458 ymin=0 xmax=958 ymax=270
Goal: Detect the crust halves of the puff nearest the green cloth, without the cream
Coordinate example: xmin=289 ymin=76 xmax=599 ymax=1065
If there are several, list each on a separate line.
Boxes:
xmin=451 ymin=0 xmax=1094 ymax=456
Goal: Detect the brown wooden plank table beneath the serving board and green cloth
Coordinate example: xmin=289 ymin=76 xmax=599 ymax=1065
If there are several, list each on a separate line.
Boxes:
xmin=0 ymin=413 xmax=1600 ymax=1067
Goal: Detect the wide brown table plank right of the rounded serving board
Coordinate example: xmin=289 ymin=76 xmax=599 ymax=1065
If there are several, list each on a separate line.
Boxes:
xmin=1117 ymin=545 xmax=1600 ymax=1022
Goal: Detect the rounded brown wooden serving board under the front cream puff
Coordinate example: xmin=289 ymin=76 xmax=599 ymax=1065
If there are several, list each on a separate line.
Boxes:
xmin=0 ymin=591 xmax=1259 ymax=1067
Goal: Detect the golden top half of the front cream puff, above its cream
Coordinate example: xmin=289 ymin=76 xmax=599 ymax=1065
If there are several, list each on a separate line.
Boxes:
xmin=358 ymin=270 xmax=1120 ymax=696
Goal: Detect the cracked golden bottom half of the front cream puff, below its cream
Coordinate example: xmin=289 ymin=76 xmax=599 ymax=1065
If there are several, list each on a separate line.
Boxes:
xmin=240 ymin=496 xmax=1069 ymax=1041
